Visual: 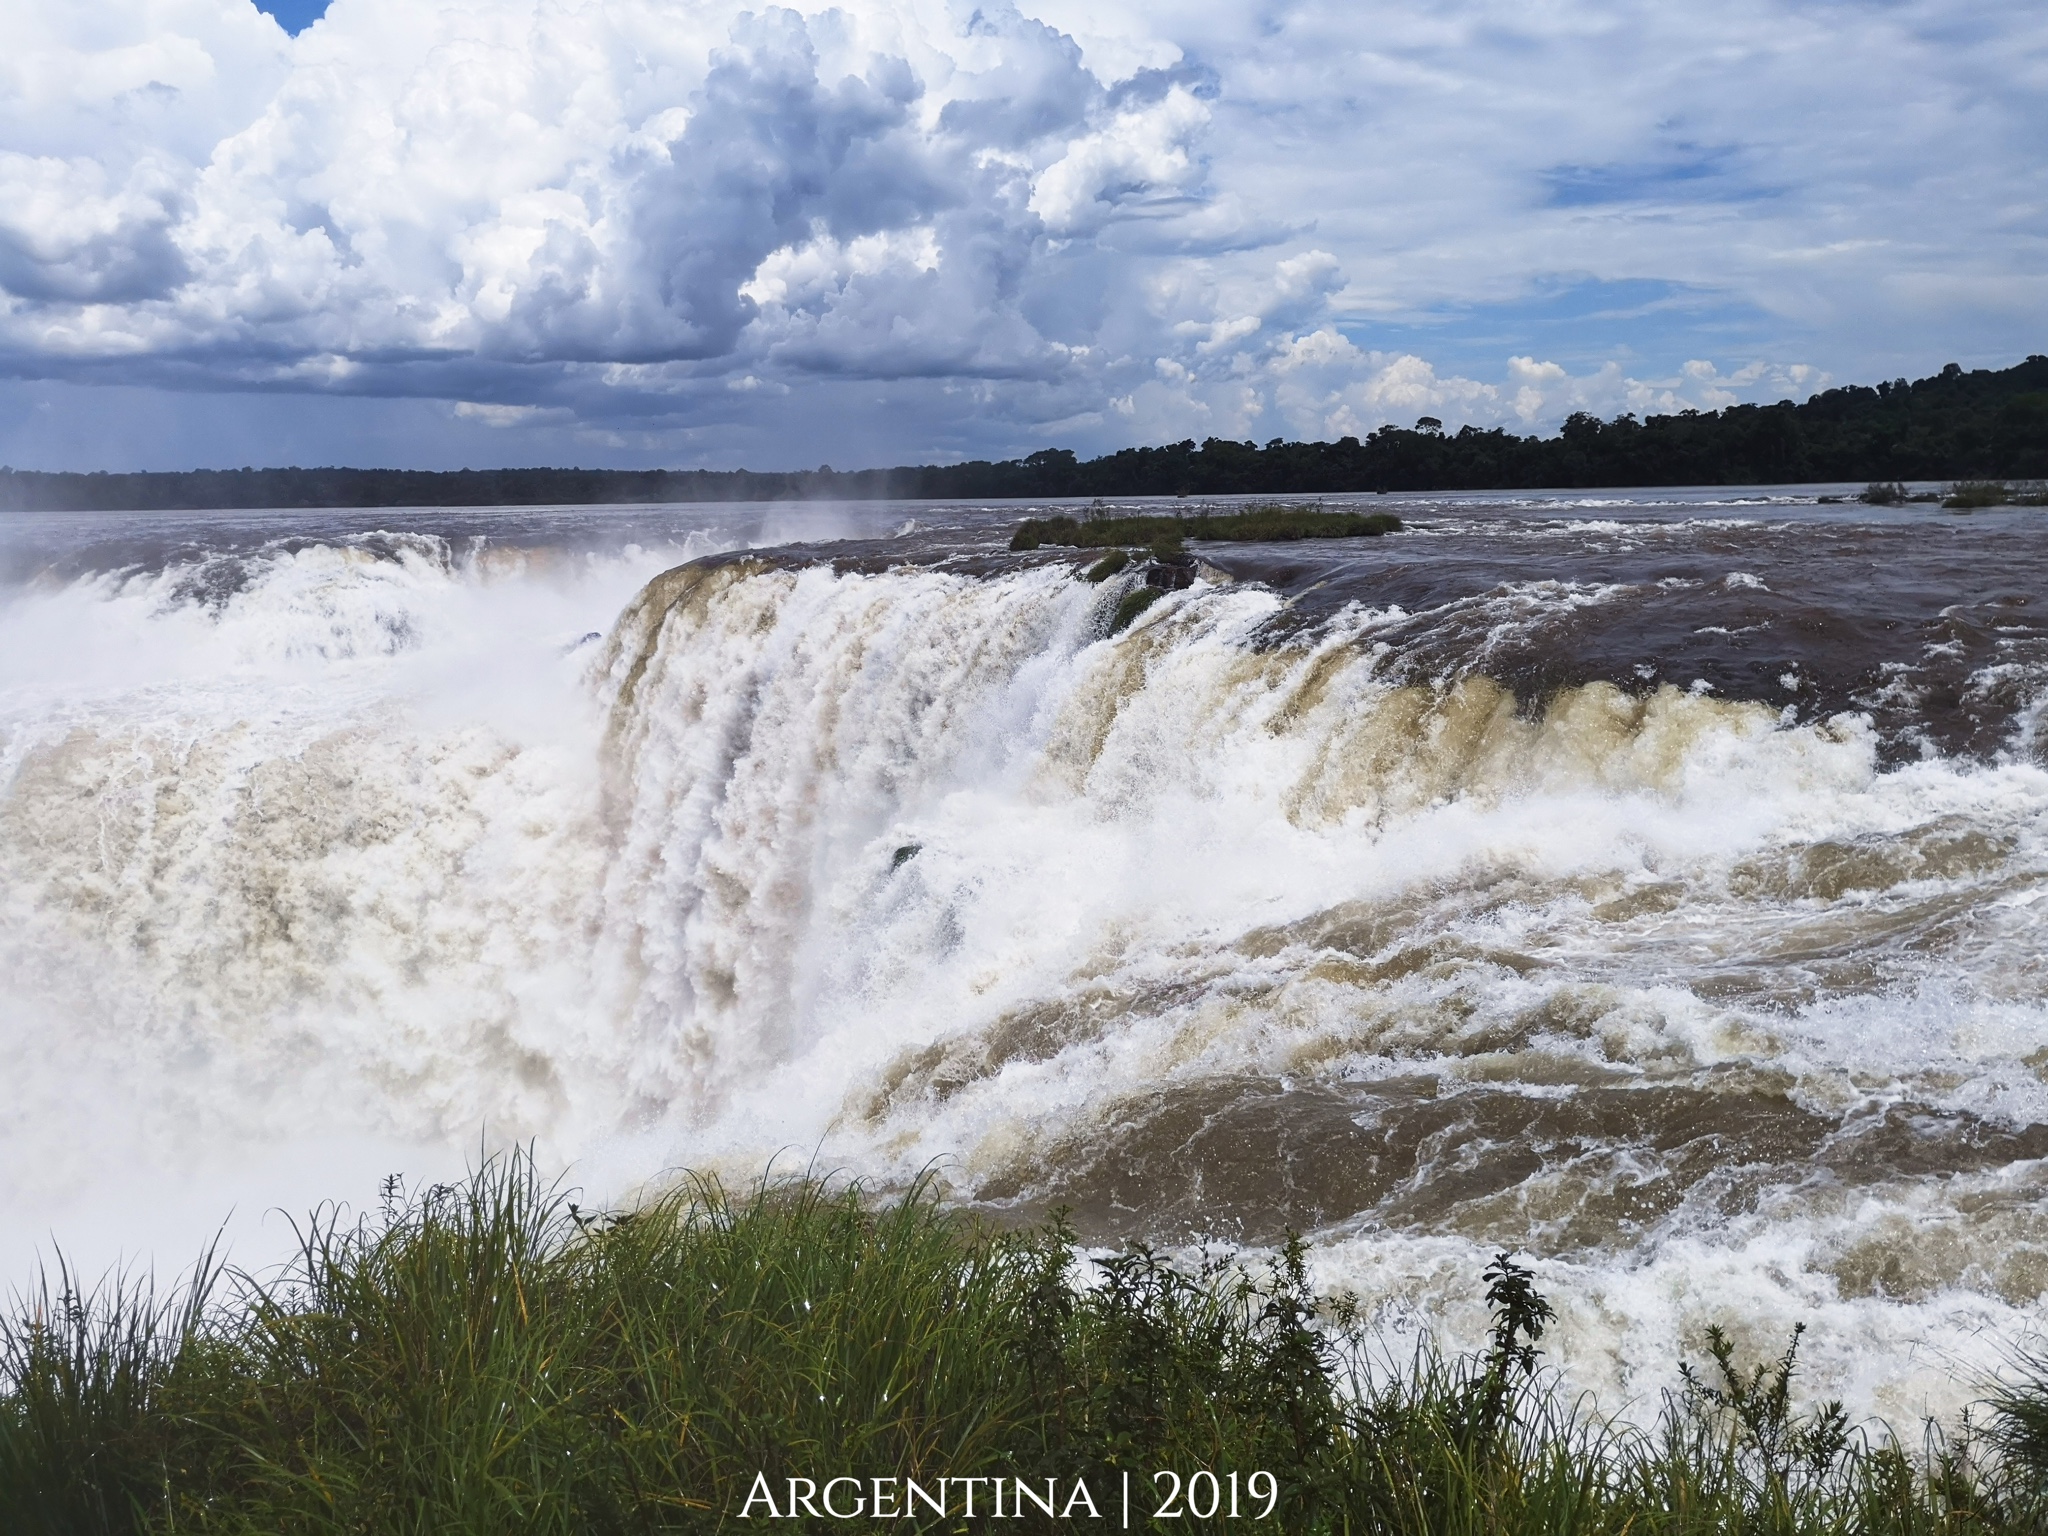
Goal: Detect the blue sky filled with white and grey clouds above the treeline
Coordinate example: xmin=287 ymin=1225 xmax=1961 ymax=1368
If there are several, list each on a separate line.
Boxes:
xmin=0 ymin=0 xmax=2048 ymax=469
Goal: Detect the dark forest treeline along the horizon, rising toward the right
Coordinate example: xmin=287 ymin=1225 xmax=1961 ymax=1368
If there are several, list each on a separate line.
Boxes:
xmin=0 ymin=354 xmax=2048 ymax=510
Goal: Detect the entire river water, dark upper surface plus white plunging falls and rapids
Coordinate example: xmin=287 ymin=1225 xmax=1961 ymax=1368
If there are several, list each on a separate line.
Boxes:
xmin=0 ymin=489 xmax=2048 ymax=1425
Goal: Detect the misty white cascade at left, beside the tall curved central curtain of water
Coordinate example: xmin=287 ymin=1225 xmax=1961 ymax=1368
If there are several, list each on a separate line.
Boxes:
xmin=0 ymin=537 xmax=692 ymax=1280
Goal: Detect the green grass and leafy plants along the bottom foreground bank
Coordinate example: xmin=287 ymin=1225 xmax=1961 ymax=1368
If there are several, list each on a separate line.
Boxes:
xmin=0 ymin=1159 xmax=2048 ymax=1536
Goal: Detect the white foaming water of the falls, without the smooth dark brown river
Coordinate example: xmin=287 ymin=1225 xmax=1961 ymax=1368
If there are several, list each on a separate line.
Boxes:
xmin=0 ymin=548 xmax=2048 ymax=1415
